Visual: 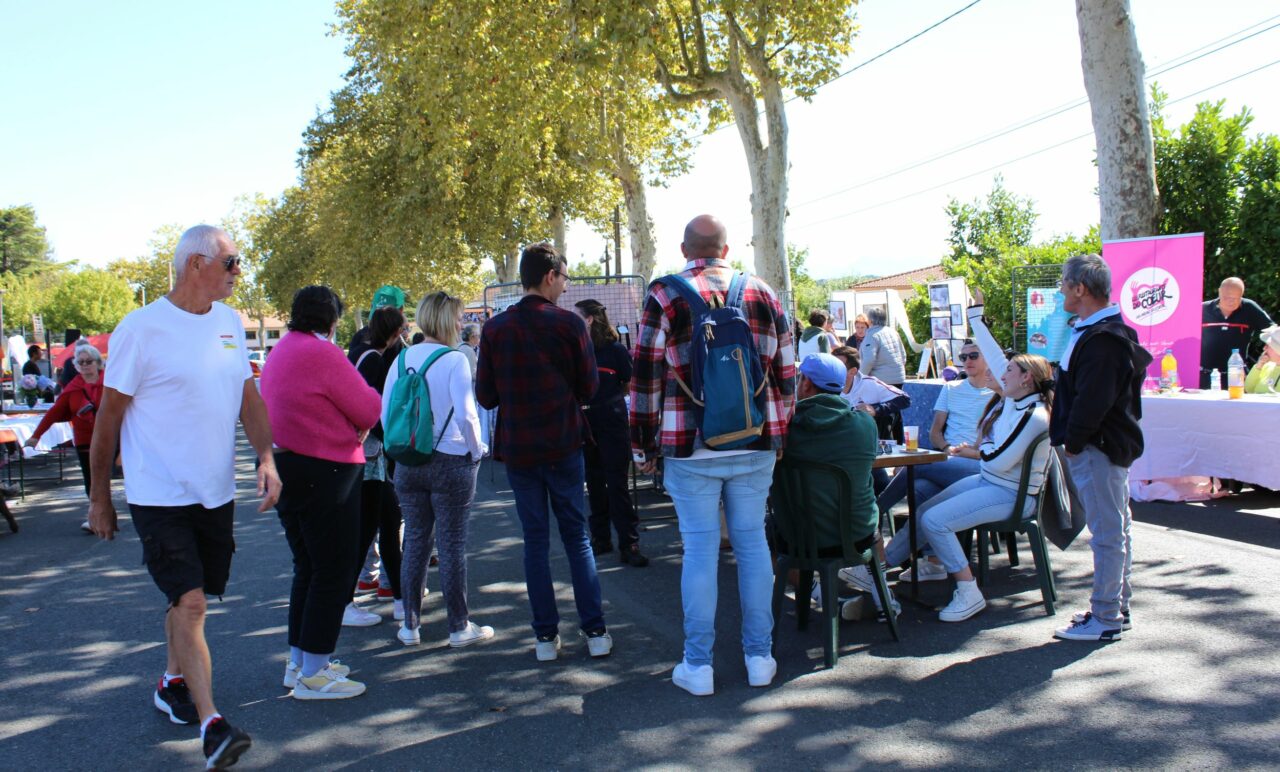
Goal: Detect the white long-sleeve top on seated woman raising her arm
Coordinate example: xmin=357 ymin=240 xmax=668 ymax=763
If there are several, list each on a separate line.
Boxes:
xmin=969 ymin=306 xmax=1051 ymax=495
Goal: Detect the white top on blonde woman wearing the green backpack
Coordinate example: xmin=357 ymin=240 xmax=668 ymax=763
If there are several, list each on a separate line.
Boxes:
xmin=383 ymin=343 xmax=488 ymax=461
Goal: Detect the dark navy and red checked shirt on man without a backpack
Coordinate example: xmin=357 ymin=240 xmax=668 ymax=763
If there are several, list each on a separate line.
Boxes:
xmin=476 ymin=294 xmax=600 ymax=466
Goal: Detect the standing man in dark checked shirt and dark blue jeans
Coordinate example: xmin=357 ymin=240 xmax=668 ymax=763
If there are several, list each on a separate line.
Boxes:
xmin=476 ymin=245 xmax=613 ymax=662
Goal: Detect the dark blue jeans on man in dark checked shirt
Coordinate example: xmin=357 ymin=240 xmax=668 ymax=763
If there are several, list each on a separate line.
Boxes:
xmin=507 ymin=453 xmax=604 ymax=638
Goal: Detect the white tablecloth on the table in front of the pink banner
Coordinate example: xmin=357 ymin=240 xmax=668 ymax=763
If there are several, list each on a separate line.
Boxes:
xmin=1129 ymin=392 xmax=1280 ymax=489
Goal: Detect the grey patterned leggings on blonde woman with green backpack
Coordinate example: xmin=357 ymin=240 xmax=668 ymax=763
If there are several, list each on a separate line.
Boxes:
xmin=396 ymin=452 xmax=480 ymax=632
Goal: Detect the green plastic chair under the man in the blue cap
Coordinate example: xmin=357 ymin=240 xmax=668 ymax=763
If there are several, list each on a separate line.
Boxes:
xmin=771 ymin=456 xmax=899 ymax=667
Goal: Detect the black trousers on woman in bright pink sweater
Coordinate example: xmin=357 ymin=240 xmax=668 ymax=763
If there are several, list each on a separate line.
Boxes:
xmin=275 ymin=452 xmax=365 ymax=654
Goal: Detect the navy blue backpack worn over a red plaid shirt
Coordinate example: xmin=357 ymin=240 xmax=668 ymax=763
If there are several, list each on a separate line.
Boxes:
xmin=658 ymin=271 xmax=767 ymax=451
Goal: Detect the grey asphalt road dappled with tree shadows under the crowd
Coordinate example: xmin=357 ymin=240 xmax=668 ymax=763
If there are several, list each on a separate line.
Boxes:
xmin=0 ymin=440 xmax=1280 ymax=771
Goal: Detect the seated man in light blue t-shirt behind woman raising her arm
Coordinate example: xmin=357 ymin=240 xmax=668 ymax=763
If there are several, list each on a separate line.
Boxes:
xmin=877 ymin=339 xmax=992 ymax=524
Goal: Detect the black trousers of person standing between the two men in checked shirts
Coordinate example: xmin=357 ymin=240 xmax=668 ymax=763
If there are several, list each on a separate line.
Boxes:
xmin=582 ymin=398 xmax=640 ymax=551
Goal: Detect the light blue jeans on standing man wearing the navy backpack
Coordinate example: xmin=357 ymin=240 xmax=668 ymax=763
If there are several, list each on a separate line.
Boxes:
xmin=663 ymin=451 xmax=777 ymax=666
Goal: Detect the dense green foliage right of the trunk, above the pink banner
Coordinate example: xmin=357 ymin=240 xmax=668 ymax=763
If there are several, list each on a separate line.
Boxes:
xmin=1152 ymin=86 xmax=1280 ymax=312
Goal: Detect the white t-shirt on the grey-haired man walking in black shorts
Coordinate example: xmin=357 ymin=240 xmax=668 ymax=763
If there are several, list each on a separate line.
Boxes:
xmin=102 ymin=297 xmax=253 ymax=508
